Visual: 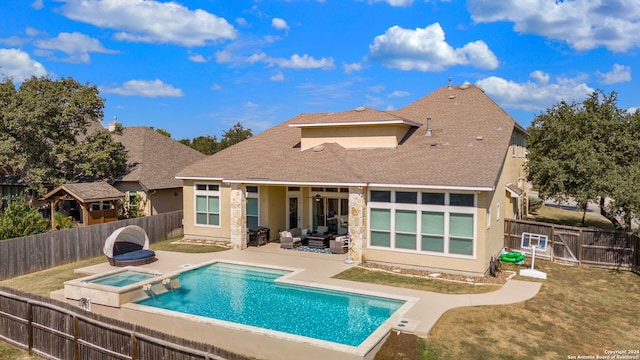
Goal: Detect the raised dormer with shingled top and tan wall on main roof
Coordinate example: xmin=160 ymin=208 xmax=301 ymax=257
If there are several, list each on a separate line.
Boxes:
xmin=289 ymin=107 xmax=420 ymax=151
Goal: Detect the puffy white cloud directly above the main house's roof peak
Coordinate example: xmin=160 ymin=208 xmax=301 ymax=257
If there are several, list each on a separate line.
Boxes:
xmin=369 ymin=23 xmax=498 ymax=71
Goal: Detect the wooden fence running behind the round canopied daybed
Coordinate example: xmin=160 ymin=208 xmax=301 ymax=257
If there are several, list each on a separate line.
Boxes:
xmin=0 ymin=210 xmax=183 ymax=280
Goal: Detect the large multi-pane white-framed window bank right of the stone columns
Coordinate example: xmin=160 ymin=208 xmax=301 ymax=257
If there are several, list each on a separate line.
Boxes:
xmin=369 ymin=190 xmax=476 ymax=256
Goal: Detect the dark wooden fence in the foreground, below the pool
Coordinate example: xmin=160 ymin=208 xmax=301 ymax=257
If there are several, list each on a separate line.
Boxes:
xmin=0 ymin=287 xmax=249 ymax=360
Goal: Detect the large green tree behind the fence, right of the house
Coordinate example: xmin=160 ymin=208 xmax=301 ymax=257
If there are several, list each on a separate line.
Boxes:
xmin=527 ymin=91 xmax=640 ymax=229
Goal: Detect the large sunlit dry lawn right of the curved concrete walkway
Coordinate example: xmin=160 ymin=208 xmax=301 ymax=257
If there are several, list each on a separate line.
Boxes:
xmin=372 ymin=260 xmax=640 ymax=359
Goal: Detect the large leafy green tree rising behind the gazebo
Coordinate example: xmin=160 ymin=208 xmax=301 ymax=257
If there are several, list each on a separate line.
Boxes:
xmin=0 ymin=77 xmax=126 ymax=195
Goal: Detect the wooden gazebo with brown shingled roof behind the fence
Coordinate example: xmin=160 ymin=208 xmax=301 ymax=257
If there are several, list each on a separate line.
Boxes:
xmin=43 ymin=181 xmax=125 ymax=225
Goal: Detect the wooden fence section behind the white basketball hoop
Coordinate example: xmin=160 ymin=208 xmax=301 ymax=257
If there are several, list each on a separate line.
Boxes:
xmin=504 ymin=219 xmax=640 ymax=272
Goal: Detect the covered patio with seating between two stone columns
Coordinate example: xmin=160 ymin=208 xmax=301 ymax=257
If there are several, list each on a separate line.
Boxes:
xmin=226 ymin=183 xmax=366 ymax=257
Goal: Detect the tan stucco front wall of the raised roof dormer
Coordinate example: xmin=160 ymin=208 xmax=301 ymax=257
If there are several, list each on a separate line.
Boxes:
xmin=300 ymin=125 xmax=408 ymax=151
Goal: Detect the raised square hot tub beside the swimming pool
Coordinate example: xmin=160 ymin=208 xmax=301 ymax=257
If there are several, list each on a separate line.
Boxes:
xmin=64 ymin=267 xmax=180 ymax=307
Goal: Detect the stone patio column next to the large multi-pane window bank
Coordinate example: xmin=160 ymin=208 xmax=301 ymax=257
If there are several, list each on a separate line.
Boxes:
xmin=349 ymin=186 xmax=367 ymax=263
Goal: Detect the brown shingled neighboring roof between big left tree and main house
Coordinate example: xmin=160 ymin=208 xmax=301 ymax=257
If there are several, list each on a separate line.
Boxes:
xmin=113 ymin=126 xmax=206 ymax=190
